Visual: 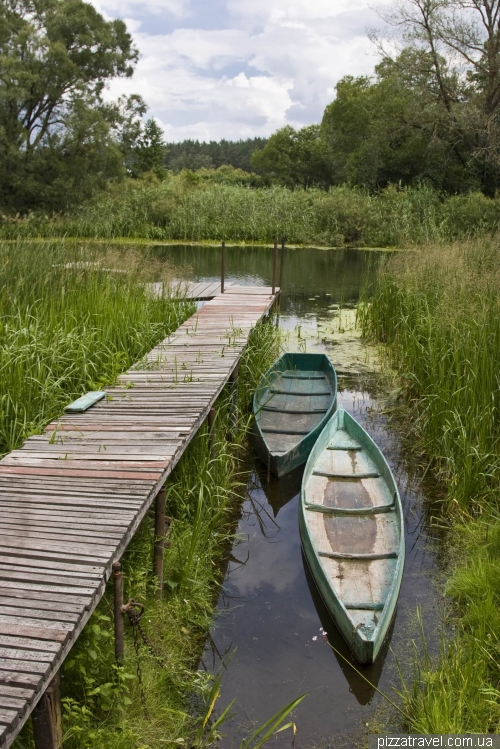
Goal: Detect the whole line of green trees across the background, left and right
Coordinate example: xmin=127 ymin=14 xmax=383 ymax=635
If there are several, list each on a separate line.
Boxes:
xmin=0 ymin=0 xmax=500 ymax=212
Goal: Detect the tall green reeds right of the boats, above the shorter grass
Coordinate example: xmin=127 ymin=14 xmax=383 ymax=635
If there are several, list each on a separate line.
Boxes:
xmin=360 ymin=236 xmax=500 ymax=507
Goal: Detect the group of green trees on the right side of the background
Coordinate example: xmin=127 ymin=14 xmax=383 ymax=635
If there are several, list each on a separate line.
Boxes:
xmin=252 ymin=0 xmax=500 ymax=196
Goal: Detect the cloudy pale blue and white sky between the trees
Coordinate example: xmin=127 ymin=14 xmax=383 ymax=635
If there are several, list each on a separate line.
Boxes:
xmin=91 ymin=0 xmax=387 ymax=141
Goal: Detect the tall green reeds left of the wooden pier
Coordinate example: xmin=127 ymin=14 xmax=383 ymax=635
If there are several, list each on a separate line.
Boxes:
xmin=0 ymin=240 xmax=194 ymax=453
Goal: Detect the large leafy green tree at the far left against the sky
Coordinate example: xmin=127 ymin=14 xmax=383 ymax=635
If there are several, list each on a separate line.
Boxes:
xmin=0 ymin=0 xmax=137 ymax=211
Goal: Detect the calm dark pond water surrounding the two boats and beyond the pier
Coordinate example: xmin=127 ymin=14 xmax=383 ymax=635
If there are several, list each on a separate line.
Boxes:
xmin=155 ymin=247 xmax=439 ymax=749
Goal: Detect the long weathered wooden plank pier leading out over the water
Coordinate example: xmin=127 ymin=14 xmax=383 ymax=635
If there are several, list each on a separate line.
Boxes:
xmin=0 ymin=286 xmax=279 ymax=749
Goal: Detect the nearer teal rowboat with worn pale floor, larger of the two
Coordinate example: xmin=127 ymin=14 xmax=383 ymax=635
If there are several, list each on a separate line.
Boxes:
xmin=299 ymin=407 xmax=405 ymax=663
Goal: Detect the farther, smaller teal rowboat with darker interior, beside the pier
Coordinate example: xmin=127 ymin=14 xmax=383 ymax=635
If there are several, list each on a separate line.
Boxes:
xmin=252 ymin=353 xmax=337 ymax=478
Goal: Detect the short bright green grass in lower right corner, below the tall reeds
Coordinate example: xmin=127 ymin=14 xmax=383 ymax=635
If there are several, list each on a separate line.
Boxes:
xmin=401 ymin=513 xmax=500 ymax=734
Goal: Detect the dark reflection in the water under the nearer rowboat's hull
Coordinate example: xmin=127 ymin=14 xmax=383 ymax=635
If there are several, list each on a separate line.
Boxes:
xmin=302 ymin=554 xmax=392 ymax=705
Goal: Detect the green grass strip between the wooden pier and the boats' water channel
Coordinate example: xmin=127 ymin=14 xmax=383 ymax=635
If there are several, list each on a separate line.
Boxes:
xmin=11 ymin=314 xmax=286 ymax=749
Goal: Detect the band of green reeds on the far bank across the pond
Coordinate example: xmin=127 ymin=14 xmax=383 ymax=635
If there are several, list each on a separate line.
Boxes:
xmin=0 ymin=175 xmax=500 ymax=247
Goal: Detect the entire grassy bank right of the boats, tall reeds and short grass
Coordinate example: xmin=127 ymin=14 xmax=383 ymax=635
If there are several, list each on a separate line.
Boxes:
xmin=360 ymin=236 xmax=500 ymax=733
